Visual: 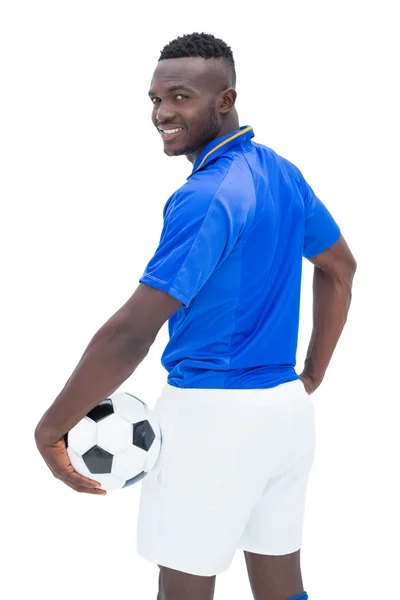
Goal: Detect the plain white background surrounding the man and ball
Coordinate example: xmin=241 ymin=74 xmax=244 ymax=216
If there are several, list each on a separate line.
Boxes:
xmin=0 ymin=0 xmax=400 ymax=600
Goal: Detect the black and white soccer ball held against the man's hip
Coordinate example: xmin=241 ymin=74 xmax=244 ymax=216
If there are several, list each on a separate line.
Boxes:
xmin=64 ymin=392 xmax=161 ymax=490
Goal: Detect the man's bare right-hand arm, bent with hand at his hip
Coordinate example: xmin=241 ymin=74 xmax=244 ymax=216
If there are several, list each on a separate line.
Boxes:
xmin=300 ymin=236 xmax=357 ymax=393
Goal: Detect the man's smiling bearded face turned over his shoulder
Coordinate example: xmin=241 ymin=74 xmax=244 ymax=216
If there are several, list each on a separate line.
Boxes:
xmin=149 ymin=57 xmax=223 ymax=156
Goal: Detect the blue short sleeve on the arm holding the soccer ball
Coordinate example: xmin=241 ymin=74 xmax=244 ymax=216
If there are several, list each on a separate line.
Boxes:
xmin=139 ymin=190 xmax=245 ymax=306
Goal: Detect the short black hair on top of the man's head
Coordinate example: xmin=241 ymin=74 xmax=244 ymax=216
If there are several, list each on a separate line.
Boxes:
xmin=158 ymin=32 xmax=236 ymax=88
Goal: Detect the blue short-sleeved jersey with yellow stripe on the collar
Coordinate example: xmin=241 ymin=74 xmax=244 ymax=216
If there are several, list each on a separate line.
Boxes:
xmin=140 ymin=126 xmax=340 ymax=389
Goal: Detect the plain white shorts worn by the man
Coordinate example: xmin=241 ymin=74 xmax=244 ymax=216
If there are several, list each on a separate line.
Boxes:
xmin=137 ymin=380 xmax=315 ymax=576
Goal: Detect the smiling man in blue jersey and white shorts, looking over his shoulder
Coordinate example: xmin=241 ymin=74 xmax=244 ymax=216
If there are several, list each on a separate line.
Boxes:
xmin=35 ymin=33 xmax=356 ymax=600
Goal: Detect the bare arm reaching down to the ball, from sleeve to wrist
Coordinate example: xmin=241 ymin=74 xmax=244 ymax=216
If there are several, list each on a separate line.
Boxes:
xmin=35 ymin=283 xmax=182 ymax=445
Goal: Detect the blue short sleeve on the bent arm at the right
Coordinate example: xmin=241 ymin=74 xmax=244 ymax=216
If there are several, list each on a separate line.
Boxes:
xmin=303 ymin=178 xmax=340 ymax=258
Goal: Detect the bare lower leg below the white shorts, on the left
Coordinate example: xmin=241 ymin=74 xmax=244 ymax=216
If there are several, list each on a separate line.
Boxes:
xmin=157 ymin=565 xmax=216 ymax=600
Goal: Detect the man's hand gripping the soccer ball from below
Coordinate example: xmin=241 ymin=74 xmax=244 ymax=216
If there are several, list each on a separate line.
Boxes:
xmin=35 ymin=435 xmax=107 ymax=496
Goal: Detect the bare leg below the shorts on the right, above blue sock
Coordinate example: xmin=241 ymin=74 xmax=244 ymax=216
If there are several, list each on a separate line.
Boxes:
xmin=244 ymin=550 xmax=304 ymax=600
